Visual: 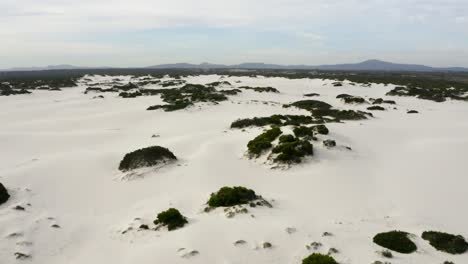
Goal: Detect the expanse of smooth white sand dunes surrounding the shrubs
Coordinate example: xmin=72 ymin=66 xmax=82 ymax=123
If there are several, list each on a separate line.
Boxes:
xmin=0 ymin=75 xmax=468 ymax=264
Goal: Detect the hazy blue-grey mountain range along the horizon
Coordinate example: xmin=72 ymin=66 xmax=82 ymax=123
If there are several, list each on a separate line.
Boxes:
xmin=0 ymin=60 xmax=468 ymax=72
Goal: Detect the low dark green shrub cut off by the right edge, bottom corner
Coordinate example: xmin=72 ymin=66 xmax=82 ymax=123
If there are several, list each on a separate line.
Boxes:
xmin=422 ymin=231 xmax=468 ymax=254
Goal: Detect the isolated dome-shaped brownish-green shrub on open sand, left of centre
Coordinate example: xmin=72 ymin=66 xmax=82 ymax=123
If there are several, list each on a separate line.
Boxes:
xmin=119 ymin=146 xmax=177 ymax=171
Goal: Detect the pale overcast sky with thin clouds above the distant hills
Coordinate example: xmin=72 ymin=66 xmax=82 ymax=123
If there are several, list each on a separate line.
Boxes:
xmin=0 ymin=0 xmax=468 ymax=68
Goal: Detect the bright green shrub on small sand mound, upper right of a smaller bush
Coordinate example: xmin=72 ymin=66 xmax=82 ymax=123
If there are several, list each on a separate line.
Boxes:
xmin=208 ymin=186 xmax=258 ymax=207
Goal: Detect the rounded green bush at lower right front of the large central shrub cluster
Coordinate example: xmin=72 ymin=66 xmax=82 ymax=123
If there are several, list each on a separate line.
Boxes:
xmin=272 ymin=135 xmax=314 ymax=163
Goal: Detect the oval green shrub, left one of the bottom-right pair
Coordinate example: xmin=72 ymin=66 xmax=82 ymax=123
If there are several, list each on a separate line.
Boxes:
xmin=373 ymin=231 xmax=417 ymax=254
